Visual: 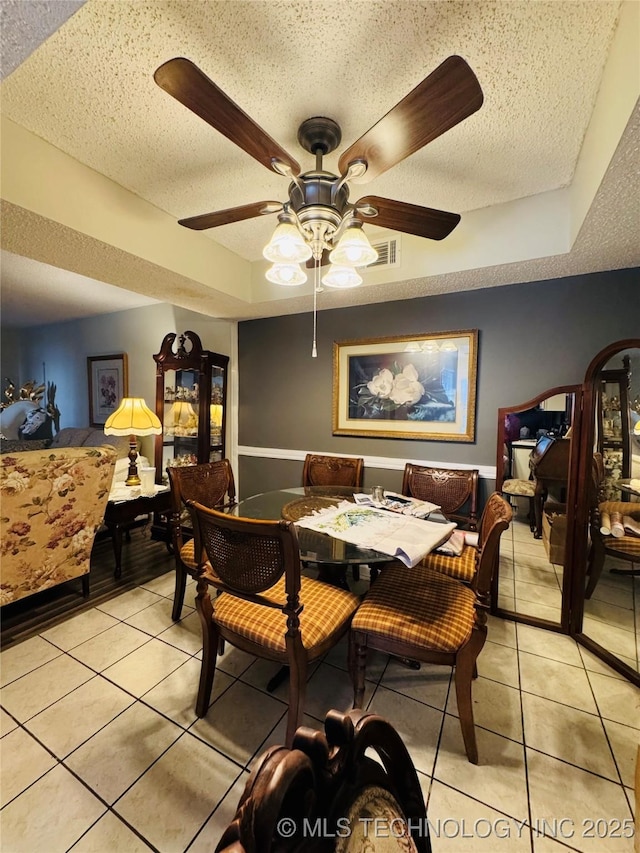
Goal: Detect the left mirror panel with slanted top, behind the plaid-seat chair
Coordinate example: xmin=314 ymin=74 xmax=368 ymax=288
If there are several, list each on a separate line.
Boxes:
xmin=492 ymin=386 xmax=578 ymax=630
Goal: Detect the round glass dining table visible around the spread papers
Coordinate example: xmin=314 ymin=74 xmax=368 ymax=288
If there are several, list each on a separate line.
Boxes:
xmin=229 ymin=486 xmax=446 ymax=566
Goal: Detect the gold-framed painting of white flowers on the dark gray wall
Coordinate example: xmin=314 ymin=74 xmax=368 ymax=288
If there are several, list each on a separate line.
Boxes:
xmin=333 ymin=329 xmax=478 ymax=441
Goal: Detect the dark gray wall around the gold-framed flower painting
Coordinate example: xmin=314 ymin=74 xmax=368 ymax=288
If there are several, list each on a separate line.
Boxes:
xmin=238 ymin=269 xmax=640 ymax=496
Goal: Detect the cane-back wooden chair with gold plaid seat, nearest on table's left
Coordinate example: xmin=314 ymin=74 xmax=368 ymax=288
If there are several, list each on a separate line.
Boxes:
xmin=189 ymin=502 xmax=360 ymax=747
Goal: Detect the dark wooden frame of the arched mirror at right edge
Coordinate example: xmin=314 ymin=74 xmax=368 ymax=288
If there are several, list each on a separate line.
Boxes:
xmin=565 ymin=338 xmax=640 ymax=687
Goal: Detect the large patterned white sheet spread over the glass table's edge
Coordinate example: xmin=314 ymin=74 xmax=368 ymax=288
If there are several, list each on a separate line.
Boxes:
xmin=296 ymin=501 xmax=456 ymax=566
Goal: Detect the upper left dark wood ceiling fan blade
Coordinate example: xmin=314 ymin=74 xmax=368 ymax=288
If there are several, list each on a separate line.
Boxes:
xmin=153 ymin=57 xmax=300 ymax=175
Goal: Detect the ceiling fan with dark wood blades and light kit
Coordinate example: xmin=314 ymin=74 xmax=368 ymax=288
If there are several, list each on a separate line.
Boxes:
xmin=154 ymin=56 xmax=483 ymax=274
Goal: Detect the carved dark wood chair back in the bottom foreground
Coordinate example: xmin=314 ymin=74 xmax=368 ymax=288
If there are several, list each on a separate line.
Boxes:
xmin=215 ymin=711 xmax=431 ymax=853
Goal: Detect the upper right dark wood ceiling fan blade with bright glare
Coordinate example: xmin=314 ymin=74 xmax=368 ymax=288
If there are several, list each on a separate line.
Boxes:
xmin=339 ymin=56 xmax=483 ymax=183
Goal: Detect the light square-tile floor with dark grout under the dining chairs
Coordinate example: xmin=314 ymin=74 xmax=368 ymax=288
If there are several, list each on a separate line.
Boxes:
xmin=0 ymin=572 xmax=640 ymax=853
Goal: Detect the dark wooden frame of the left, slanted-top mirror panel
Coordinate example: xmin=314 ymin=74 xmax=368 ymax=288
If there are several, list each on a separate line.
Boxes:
xmin=491 ymin=385 xmax=581 ymax=634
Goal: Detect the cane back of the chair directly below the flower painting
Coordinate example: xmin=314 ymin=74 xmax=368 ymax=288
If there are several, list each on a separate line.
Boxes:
xmin=402 ymin=462 xmax=479 ymax=530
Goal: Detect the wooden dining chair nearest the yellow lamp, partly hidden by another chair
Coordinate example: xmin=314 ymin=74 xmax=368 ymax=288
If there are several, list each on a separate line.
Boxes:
xmin=167 ymin=459 xmax=236 ymax=622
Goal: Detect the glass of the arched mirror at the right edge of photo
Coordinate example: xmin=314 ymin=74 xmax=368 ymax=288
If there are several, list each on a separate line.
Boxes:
xmin=574 ymin=341 xmax=640 ymax=683
